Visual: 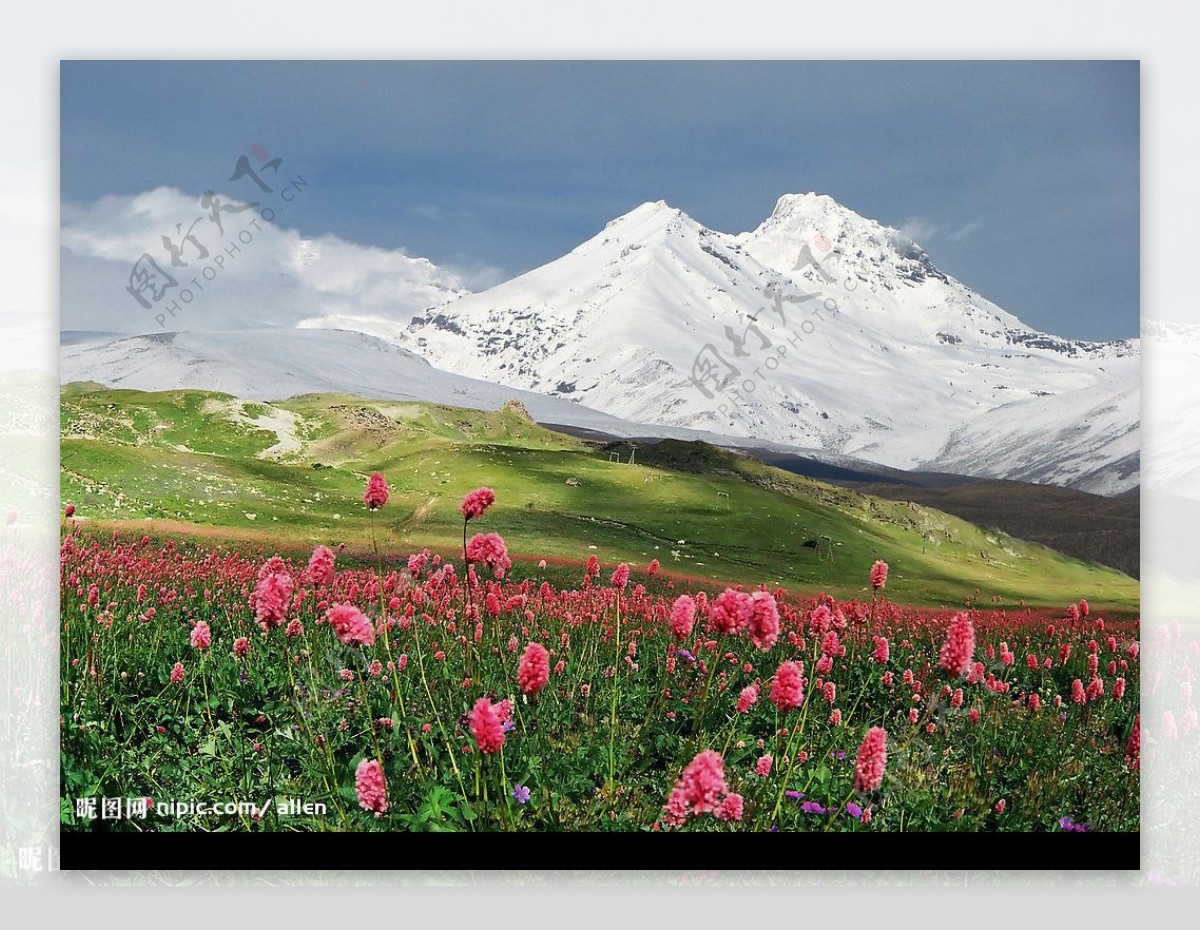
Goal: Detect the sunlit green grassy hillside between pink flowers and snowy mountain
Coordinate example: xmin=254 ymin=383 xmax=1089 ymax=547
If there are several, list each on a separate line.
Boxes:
xmin=61 ymin=384 xmax=1138 ymax=612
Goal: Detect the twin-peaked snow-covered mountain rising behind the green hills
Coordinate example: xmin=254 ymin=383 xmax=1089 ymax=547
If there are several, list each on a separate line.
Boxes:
xmin=398 ymin=193 xmax=1139 ymax=493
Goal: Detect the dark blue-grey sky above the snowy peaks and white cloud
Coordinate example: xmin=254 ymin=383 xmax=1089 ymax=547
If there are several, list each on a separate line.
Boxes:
xmin=60 ymin=61 xmax=1140 ymax=338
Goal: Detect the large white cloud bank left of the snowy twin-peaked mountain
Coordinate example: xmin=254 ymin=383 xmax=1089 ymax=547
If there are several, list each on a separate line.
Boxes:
xmin=60 ymin=187 xmax=470 ymax=332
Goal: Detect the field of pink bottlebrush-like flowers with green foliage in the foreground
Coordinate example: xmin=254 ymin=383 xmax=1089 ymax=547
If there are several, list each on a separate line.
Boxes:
xmin=60 ymin=474 xmax=1140 ymax=832
